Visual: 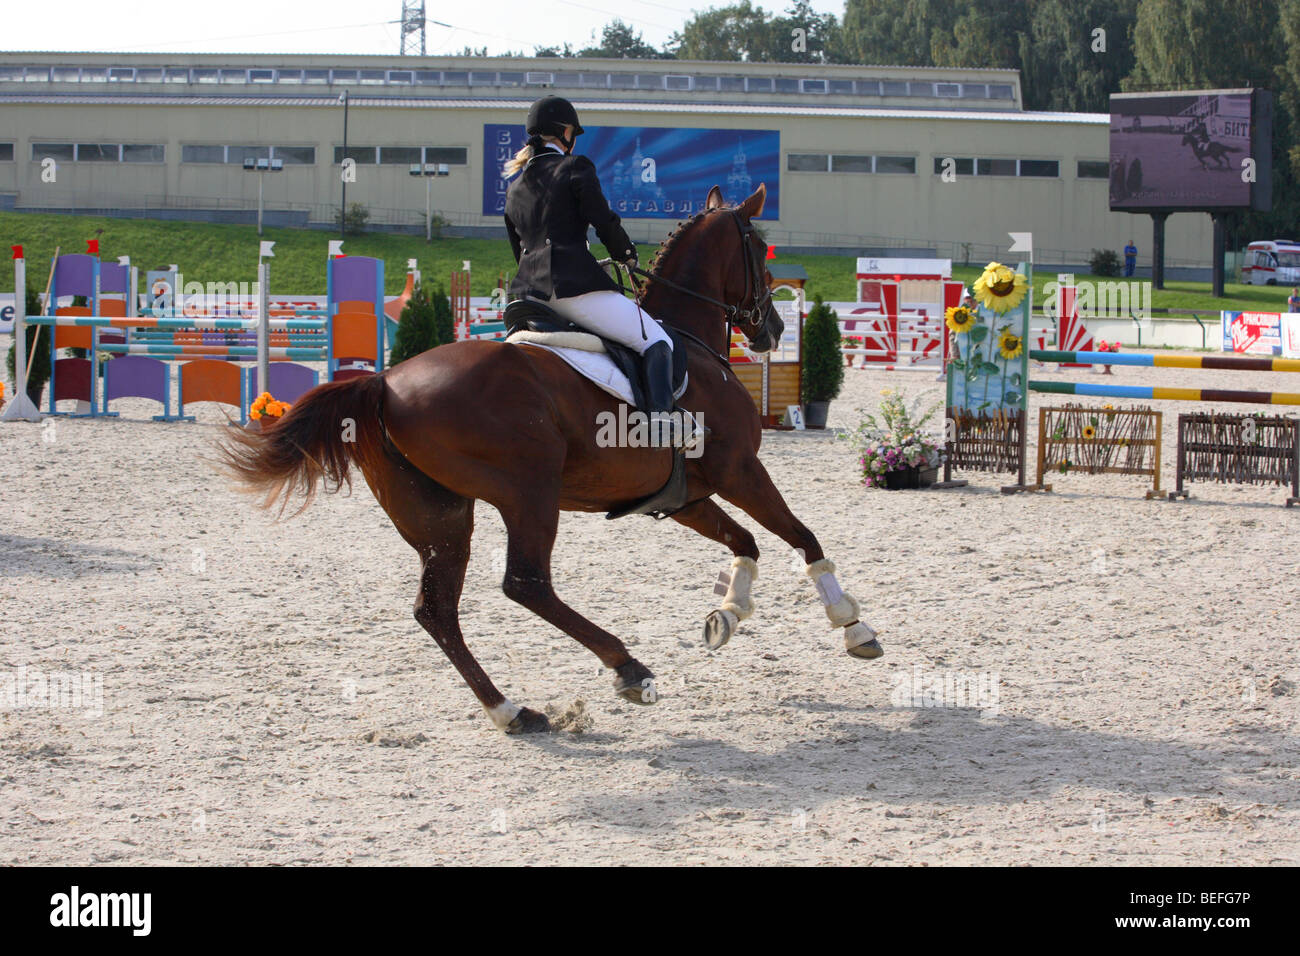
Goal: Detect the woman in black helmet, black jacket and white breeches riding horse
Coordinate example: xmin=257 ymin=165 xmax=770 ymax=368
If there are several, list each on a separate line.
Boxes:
xmin=504 ymin=96 xmax=673 ymax=442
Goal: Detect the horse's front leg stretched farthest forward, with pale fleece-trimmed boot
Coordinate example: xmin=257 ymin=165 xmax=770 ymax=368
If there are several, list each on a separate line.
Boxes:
xmin=719 ymin=457 xmax=885 ymax=659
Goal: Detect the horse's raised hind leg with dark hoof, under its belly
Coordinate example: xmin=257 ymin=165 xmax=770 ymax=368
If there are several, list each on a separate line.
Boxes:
xmin=498 ymin=502 xmax=658 ymax=704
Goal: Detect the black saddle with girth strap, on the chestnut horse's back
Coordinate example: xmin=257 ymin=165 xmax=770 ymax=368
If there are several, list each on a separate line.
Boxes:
xmin=504 ymin=299 xmax=690 ymax=520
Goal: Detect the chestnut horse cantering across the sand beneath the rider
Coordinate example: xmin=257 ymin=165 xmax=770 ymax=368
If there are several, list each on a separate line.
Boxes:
xmin=221 ymin=185 xmax=884 ymax=734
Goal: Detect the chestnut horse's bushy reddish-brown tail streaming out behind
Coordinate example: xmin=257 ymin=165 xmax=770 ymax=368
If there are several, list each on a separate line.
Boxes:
xmin=221 ymin=375 xmax=385 ymax=511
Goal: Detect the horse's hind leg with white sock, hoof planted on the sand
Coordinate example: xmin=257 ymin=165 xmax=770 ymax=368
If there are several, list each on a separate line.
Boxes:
xmin=367 ymin=459 xmax=550 ymax=734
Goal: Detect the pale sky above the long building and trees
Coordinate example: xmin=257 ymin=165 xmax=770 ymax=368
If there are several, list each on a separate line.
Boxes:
xmin=0 ymin=0 xmax=844 ymax=56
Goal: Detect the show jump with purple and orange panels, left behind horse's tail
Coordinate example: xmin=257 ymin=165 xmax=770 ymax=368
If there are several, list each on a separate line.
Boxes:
xmin=5 ymin=243 xmax=385 ymax=421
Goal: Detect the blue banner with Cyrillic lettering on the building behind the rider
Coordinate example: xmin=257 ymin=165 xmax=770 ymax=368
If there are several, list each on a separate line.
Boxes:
xmin=482 ymin=124 xmax=781 ymax=219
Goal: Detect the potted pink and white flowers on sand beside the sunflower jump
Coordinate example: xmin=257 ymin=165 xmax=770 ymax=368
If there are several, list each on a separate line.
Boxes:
xmin=849 ymin=389 xmax=943 ymax=490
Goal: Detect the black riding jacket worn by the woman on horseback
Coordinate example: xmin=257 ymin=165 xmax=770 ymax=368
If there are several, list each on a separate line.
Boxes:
xmin=506 ymin=148 xmax=636 ymax=299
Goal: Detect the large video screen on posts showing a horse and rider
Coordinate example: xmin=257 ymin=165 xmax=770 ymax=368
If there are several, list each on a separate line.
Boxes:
xmin=1110 ymin=90 xmax=1273 ymax=212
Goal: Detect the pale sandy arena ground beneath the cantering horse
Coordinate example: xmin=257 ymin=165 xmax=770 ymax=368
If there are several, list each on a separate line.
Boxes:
xmin=0 ymin=356 xmax=1300 ymax=865
